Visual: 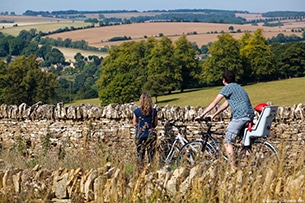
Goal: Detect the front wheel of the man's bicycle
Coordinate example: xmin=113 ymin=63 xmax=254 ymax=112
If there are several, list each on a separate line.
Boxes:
xmin=178 ymin=140 xmax=217 ymax=166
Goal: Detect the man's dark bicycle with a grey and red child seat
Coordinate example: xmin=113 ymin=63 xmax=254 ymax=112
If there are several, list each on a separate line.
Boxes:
xmin=179 ymin=106 xmax=279 ymax=171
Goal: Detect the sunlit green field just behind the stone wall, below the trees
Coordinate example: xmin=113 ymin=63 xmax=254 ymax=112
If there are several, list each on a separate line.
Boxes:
xmin=72 ymin=78 xmax=305 ymax=107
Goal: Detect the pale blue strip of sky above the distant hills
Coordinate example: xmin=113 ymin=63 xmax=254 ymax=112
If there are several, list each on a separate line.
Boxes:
xmin=0 ymin=0 xmax=305 ymax=15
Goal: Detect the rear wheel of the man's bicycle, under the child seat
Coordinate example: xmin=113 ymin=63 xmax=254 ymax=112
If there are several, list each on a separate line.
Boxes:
xmin=237 ymin=140 xmax=279 ymax=170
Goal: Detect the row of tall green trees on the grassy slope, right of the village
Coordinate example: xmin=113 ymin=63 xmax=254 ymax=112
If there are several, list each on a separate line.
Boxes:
xmin=97 ymin=29 xmax=305 ymax=105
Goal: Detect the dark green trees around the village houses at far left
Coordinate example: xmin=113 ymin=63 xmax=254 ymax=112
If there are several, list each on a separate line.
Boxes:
xmin=0 ymin=31 xmax=103 ymax=104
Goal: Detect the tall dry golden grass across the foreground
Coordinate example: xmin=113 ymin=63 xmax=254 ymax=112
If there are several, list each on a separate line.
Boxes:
xmin=0 ymin=134 xmax=305 ymax=203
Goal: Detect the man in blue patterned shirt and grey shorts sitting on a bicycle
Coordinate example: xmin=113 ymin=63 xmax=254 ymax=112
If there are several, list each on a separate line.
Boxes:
xmin=195 ymin=70 xmax=254 ymax=171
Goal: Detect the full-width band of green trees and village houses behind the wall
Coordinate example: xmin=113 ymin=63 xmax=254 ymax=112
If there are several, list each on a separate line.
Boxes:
xmin=0 ymin=29 xmax=305 ymax=105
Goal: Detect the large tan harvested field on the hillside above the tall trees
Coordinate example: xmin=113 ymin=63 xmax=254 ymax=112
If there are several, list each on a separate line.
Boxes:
xmin=48 ymin=22 xmax=305 ymax=47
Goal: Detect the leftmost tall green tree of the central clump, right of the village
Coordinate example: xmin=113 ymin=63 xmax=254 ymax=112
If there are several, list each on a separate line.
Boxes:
xmin=97 ymin=41 xmax=147 ymax=105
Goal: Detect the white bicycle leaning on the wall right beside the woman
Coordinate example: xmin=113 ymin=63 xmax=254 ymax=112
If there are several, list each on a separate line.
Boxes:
xmin=158 ymin=122 xmax=189 ymax=165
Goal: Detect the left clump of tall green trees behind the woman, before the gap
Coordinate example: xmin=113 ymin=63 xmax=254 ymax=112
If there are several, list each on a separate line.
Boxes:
xmin=97 ymin=36 xmax=198 ymax=105
